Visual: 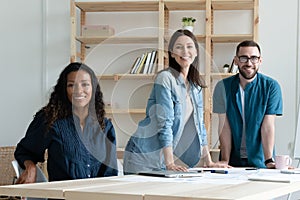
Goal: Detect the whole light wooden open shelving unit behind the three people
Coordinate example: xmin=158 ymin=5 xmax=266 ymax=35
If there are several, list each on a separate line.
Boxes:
xmin=70 ymin=0 xmax=259 ymax=147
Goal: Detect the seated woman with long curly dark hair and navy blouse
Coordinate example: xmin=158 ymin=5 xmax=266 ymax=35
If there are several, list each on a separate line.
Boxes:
xmin=15 ymin=63 xmax=118 ymax=183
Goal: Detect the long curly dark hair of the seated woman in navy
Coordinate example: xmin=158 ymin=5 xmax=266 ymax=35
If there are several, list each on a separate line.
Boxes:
xmin=41 ymin=62 xmax=105 ymax=130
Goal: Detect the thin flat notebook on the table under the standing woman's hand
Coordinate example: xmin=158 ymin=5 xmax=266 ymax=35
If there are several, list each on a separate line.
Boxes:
xmin=138 ymin=170 xmax=202 ymax=178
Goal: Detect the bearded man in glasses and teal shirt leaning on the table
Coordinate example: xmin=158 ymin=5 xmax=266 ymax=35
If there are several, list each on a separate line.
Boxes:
xmin=213 ymin=41 xmax=282 ymax=168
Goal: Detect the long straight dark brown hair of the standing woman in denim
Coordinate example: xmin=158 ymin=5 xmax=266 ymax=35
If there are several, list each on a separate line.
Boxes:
xmin=168 ymin=29 xmax=206 ymax=88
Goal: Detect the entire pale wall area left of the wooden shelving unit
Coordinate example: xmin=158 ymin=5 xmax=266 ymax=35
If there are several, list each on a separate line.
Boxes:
xmin=0 ymin=0 xmax=70 ymax=146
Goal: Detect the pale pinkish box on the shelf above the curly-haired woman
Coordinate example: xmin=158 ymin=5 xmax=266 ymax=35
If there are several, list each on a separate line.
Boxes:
xmin=82 ymin=25 xmax=115 ymax=37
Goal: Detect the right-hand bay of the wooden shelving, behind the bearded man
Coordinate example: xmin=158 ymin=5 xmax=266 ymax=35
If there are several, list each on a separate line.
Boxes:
xmin=204 ymin=0 xmax=259 ymax=144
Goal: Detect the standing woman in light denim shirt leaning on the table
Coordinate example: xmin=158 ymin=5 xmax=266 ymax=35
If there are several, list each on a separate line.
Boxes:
xmin=124 ymin=30 xmax=229 ymax=174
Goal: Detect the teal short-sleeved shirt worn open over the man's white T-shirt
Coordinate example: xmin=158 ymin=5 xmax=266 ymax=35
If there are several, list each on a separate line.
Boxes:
xmin=213 ymin=73 xmax=282 ymax=168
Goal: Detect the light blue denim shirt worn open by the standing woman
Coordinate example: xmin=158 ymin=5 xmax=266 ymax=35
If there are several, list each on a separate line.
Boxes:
xmin=124 ymin=68 xmax=207 ymax=172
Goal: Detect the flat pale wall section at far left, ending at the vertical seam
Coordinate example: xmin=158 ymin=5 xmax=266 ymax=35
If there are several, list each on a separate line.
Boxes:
xmin=0 ymin=0 xmax=44 ymax=145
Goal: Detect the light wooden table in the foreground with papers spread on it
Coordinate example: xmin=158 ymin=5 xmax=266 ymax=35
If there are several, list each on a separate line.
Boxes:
xmin=0 ymin=169 xmax=300 ymax=200
